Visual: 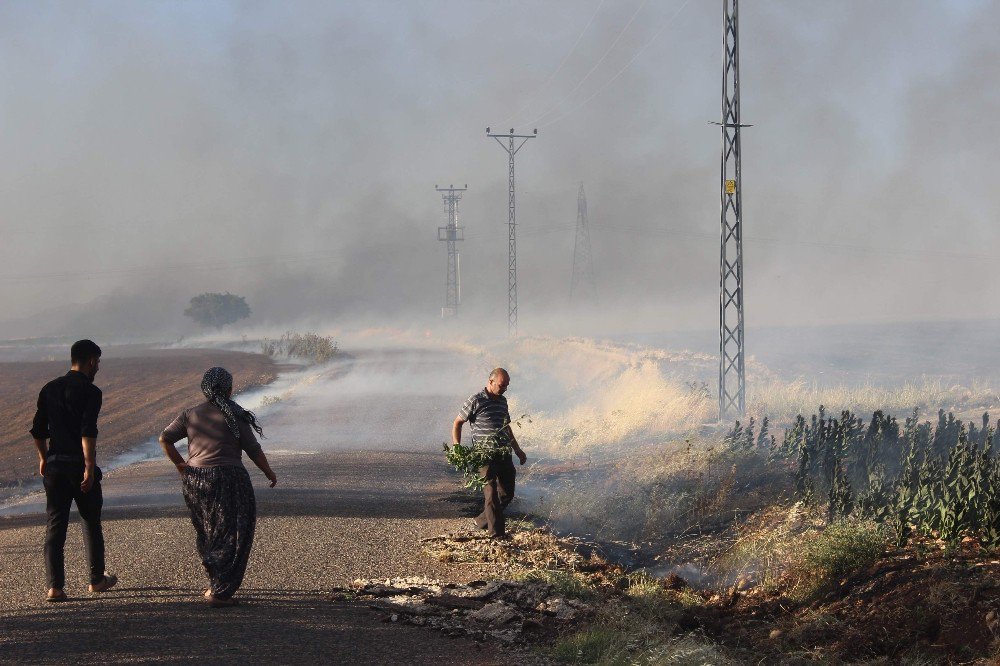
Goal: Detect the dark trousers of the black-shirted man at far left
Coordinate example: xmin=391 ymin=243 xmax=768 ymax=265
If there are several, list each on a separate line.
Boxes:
xmin=44 ymin=471 xmax=104 ymax=590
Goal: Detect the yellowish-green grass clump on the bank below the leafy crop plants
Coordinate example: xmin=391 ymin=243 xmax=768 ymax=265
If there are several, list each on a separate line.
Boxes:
xmin=790 ymin=521 xmax=886 ymax=602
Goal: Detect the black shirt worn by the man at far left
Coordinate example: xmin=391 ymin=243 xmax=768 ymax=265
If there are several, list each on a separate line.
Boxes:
xmin=31 ymin=370 xmax=104 ymax=469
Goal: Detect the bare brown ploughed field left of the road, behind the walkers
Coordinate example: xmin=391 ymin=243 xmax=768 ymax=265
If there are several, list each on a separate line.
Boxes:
xmin=0 ymin=347 xmax=278 ymax=488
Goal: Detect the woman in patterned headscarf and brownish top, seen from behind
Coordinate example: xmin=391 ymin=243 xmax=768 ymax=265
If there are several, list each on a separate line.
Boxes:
xmin=160 ymin=368 xmax=278 ymax=607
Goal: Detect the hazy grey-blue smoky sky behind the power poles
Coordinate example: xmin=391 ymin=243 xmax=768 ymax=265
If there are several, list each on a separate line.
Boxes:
xmin=0 ymin=0 xmax=1000 ymax=337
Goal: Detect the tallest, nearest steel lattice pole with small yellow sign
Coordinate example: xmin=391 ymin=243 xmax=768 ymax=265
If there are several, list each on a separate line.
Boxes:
xmin=715 ymin=0 xmax=750 ymax=420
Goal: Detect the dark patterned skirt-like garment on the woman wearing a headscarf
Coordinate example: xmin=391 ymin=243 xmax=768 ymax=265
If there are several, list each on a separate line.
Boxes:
xmin=184 ymin=466 xmax=257 ymax=598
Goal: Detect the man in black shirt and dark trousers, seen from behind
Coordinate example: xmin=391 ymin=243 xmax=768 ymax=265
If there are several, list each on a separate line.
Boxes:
xmin=31 ymin=340 xmax=118 ymax=601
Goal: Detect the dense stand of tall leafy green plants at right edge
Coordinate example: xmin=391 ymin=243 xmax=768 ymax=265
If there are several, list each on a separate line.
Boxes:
xmin=768 ymin=406 xmax=1000 ymax=547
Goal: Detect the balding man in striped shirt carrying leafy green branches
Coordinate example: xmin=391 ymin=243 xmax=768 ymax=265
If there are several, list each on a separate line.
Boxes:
xmin=451 ymin=368 xmax=528 ymax=537
